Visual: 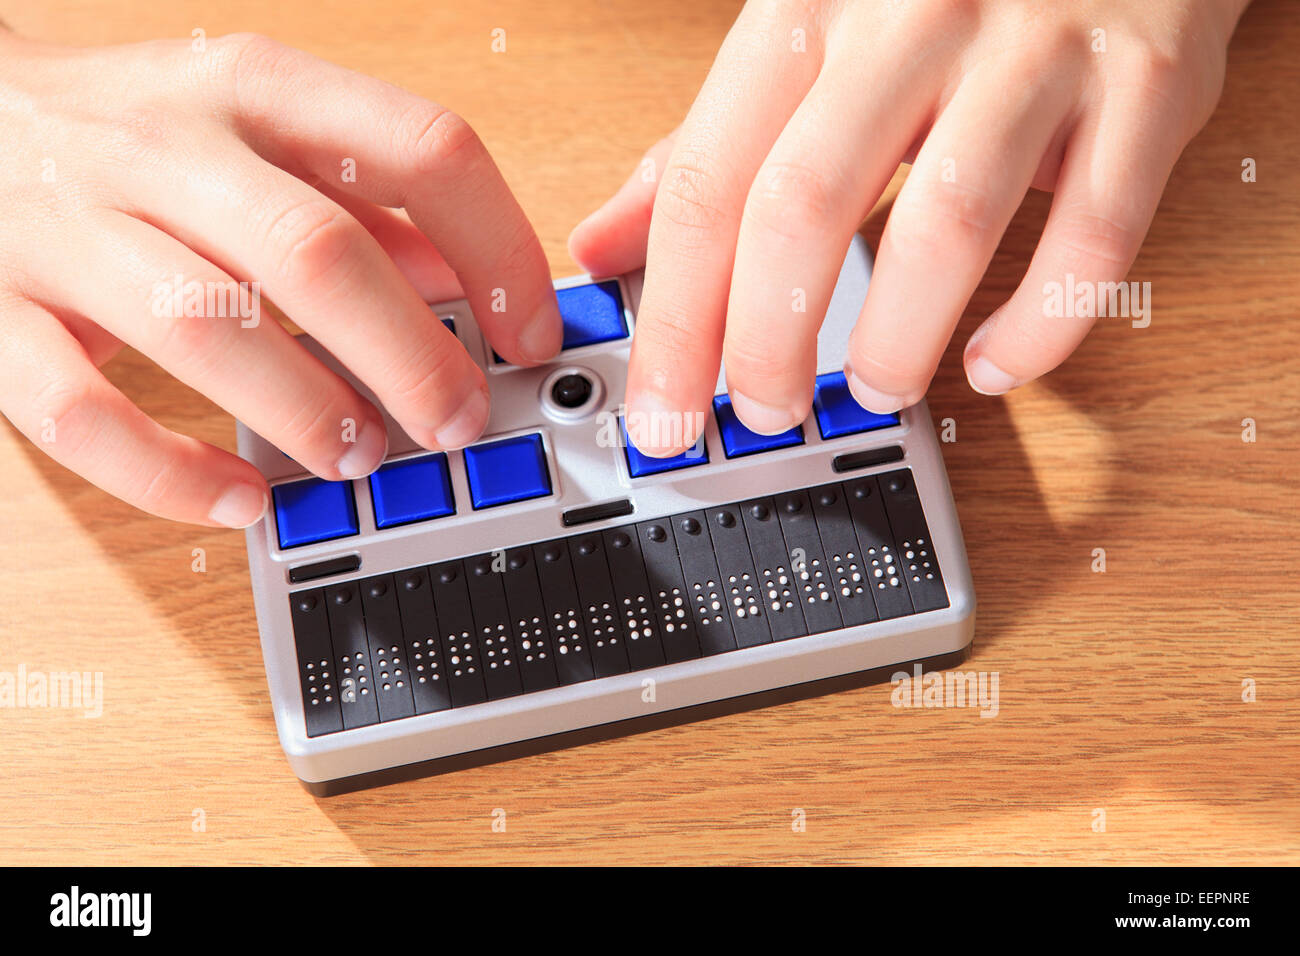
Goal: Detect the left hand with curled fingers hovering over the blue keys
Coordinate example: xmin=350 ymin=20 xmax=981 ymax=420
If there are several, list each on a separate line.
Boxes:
xmin=0 ymin=29 xmax=562 ymax=527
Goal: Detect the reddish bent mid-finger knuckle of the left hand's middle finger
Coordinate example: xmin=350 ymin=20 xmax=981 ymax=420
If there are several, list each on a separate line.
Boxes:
xmin=267 ymin=199 xmax=364 ymax=294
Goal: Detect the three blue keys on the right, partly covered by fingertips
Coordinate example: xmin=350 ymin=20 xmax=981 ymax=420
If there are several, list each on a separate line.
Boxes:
xmin=623 ymin=372 xmax=898 ymax=477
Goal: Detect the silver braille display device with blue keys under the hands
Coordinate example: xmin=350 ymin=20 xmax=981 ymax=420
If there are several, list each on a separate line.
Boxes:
xmin=239 ymin=238 xmax=975 ymax=795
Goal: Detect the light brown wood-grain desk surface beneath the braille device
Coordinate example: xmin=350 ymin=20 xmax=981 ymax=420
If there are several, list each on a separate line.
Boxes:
xmin=0 ymin=0 xmax=1300 ymax=864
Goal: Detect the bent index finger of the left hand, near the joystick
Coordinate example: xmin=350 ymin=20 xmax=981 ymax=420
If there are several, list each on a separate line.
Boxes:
xmin=206 ymin=35 xmax=562 ymax=365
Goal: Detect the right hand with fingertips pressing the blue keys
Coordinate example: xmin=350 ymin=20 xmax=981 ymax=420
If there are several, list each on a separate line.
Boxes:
xmin=569 ymin=0 xmax=1247 ymax=455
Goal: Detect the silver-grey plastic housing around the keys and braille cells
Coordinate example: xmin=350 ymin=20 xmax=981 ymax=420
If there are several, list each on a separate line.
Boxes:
xmin=238 ymin=237 xmax=975 ymax=783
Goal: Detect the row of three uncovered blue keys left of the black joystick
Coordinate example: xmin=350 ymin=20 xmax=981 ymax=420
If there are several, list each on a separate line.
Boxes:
xmin=272 ymin=432 xmax=551 ymax=548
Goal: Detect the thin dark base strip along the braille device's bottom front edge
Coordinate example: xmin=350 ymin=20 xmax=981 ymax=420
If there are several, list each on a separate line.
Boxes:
xmin=299 ymin=644 xmax=971 ymax=797
